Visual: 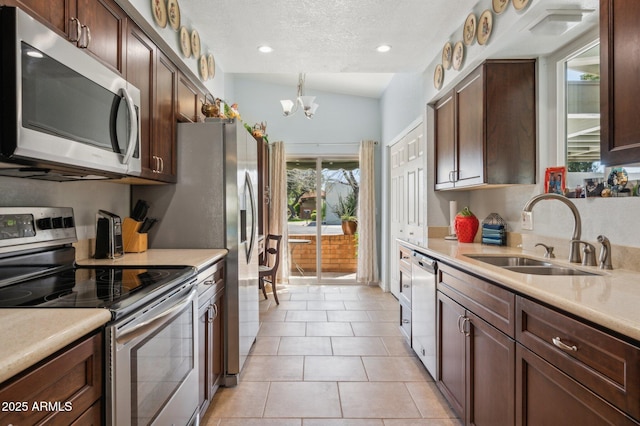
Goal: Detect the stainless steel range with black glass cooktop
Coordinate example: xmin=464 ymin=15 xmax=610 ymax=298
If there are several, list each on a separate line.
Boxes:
xmin=0 ymin=207 xmax=198 ymax=425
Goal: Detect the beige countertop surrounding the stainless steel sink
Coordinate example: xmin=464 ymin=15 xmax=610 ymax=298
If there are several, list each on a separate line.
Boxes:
xmin=399 ymin=238 xmax=640 ymax=344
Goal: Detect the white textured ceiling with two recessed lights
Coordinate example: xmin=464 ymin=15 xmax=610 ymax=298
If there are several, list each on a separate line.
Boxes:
xmin=174 ymin=0 xmax=598 ymax=96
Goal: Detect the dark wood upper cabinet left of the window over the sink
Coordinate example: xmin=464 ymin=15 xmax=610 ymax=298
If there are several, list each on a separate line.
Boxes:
xmin=433 ymin=59 xmax=536 ymax=190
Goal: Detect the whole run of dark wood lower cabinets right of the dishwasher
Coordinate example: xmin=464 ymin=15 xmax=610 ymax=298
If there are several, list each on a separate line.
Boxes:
xmin=437 ymin=262 xmax=640 ymax=426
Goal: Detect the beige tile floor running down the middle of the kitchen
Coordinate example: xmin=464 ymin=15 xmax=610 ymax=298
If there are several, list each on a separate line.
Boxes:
xmin=201 ymin=285 xmax=461 ymax=426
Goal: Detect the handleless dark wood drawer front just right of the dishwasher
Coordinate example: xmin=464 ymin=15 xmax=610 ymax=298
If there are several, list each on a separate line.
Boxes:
xmin=438 ymin=263 xmax=515 ymax=337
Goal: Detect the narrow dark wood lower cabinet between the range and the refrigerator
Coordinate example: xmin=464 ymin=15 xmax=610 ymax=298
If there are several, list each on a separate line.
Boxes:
xmin=198 ymin=262 xmax=224 ymax=417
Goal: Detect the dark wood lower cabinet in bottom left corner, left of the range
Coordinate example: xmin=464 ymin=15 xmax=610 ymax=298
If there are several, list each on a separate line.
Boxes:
xmin=0 ymin=332 xmax=104 ymax=425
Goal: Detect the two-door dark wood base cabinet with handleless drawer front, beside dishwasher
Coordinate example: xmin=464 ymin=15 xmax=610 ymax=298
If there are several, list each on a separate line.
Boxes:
xmin=437 ymin=265 xmax=515 ymax=425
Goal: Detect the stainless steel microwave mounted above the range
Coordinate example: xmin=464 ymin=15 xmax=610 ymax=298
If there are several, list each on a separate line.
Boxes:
xmin=0 ymin=7 xmax=141 ymax=180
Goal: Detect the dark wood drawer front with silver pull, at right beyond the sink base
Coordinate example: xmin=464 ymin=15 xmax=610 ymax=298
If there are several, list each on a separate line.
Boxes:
xmin=516 ymin=296 xmax=640 ymax=419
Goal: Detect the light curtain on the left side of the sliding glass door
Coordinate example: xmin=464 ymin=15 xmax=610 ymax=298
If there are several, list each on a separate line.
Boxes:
xmin=269 ymin=142 xmax=289 ymax=282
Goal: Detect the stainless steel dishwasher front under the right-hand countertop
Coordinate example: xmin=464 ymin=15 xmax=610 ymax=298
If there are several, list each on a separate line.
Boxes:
xmin=411 ymin=251 xmax=437 ymax=379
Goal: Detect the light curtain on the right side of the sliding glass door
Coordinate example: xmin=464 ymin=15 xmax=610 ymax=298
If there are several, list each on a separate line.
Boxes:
xmin=356 ymin=141 xmax=378 ymax=284
